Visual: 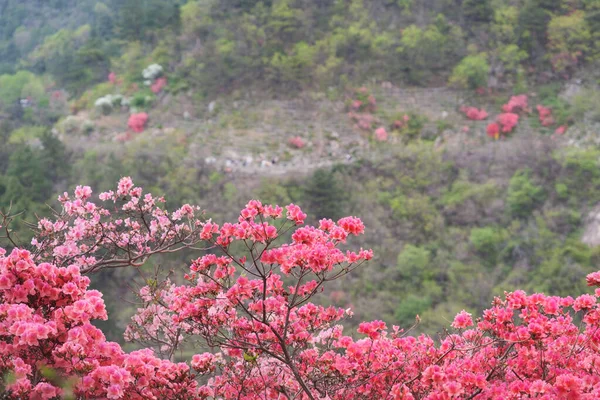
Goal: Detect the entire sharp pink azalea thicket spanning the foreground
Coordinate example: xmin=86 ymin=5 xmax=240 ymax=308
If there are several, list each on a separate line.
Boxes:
xmin=0 ymin=178 xmax=600 ymax=400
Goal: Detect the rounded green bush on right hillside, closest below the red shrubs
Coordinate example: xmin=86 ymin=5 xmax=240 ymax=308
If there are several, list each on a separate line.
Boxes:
xmin=506 ymin=170 xmax=545 ymax=217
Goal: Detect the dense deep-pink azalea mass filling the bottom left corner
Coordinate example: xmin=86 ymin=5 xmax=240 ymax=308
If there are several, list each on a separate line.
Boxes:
xmin=0 ymin=249 xmax=198 ymax=399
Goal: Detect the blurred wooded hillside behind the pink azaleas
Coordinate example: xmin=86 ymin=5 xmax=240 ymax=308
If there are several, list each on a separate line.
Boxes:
xmin=0 ymin=0 xmax=600 ymax=341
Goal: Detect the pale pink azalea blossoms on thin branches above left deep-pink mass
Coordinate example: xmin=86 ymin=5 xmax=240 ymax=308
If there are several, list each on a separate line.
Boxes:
xmin=32 ymin=177 xmax=209 ymax=274
